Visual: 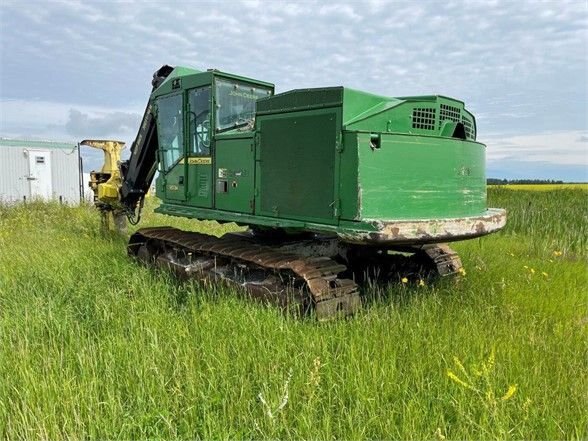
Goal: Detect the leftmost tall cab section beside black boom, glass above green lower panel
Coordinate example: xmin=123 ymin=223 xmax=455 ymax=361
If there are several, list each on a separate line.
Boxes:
xmin=157 ymin=93 xmax=187 ymax=201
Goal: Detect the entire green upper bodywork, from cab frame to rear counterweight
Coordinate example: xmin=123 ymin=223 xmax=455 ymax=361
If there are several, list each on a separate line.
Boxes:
xmin=152 ymin=69 xmax=487 ymax=242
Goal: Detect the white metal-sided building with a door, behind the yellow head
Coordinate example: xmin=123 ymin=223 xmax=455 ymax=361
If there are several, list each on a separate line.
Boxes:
xmin=0 ymin=138 xmax=84 ymax=203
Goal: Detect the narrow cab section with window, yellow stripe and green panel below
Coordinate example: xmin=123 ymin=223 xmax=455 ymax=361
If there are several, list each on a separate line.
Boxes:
xmin=186 ymin=86 xmax=213 ymax=208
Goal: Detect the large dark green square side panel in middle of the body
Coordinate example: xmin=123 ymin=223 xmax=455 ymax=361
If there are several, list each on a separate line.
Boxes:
xmin=256 ymin=107 xmax=341 ymax=223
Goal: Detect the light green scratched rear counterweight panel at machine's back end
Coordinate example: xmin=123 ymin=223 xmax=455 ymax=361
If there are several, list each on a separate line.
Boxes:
xmin=356 ymin=133 xmax=486 ymax=220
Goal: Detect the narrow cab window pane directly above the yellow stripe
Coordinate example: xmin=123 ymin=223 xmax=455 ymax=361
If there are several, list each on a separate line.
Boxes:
xmin=188 ymin=86 xmax=211 ymax=156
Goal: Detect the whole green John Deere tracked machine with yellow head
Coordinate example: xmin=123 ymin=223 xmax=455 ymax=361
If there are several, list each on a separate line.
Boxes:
xmin=82 ymin=66 xmax=506 ymax=320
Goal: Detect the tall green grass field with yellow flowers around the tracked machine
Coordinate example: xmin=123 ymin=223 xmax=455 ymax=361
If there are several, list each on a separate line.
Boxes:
xmin=0 ymin=188 xmax=588 ymax=440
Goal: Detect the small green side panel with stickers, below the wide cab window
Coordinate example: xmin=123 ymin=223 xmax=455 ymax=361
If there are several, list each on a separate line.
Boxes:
xmin=215 ymin=133 xmax=255 ymax=213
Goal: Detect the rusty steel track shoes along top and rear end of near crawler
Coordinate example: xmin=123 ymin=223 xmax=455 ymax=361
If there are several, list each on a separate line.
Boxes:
xmin=129 ymin=227 xmax=361 ymax=320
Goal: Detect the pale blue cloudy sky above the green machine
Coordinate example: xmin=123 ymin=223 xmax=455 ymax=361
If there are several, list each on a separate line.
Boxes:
xmin=0 ymin=0 xmax=588 ymax=181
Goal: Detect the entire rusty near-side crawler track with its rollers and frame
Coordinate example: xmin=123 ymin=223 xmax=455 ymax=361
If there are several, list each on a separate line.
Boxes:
xmin=128 ymin=227 xmax=361 ymax=321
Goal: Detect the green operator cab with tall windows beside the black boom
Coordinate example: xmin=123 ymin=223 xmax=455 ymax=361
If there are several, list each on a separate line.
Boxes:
xmin=152 ymin=67 xmax=274 ymax=208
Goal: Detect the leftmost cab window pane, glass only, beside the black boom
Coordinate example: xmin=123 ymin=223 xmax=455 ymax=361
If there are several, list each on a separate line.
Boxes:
xmin=157 ymin=94 xmax=184 ymax=170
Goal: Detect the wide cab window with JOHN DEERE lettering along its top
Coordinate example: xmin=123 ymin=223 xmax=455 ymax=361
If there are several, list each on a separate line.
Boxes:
xmin=216 ymin=80 xmax=272 ymax=131
